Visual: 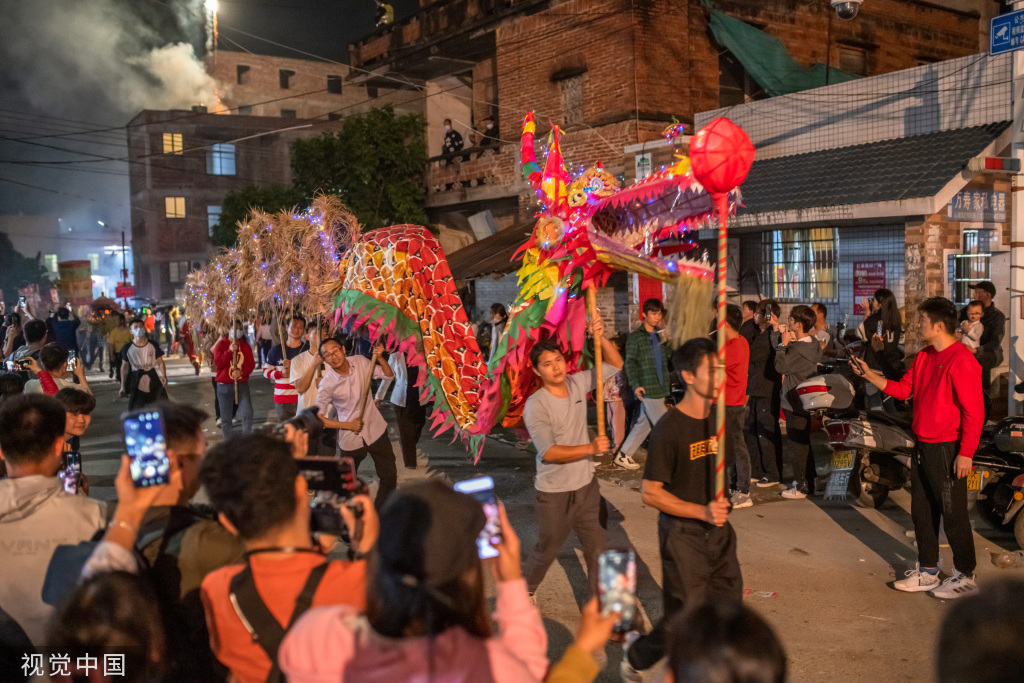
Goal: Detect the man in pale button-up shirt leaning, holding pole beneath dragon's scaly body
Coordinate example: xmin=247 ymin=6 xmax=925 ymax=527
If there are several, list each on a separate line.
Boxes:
xmin=316 ymin=339 xmax=398 ymax=509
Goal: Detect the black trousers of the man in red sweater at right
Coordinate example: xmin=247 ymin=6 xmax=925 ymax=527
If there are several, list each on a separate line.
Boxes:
xmin=910 ymin=441 xmax=978 ymax=577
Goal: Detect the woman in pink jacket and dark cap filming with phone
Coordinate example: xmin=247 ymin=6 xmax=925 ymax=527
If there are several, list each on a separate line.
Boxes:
xmin=278 ymin=479 xmax=548 ymax=683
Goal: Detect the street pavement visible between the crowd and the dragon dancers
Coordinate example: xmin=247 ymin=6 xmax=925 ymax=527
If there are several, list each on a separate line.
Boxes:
xmin=74 ymin=358 xmax=1024 ymax=683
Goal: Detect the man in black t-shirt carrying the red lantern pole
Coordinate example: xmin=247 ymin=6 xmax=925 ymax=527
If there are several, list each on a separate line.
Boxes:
xmin=622 ymin=338 xmax=743 ymax=681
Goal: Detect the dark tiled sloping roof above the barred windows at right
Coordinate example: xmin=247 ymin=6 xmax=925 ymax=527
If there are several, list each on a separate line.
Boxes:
xmin=740 ymin=121 xmax=1010 ymax=214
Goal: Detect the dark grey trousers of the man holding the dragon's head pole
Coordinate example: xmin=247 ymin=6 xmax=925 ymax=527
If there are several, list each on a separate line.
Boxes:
xmin=523 ymin=476 xmax=608 ymax=595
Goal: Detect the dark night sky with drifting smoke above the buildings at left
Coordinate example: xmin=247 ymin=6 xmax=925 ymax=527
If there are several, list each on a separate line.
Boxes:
xmin=0 ymin=0 xmax=419 ymax=228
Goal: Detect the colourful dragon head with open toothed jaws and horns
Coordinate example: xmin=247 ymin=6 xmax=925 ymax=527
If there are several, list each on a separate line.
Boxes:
xmin=520 ymin=113 xmax=735 ymax=284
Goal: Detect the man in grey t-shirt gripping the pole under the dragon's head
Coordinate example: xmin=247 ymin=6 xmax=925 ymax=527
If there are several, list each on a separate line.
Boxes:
xmin=523 ymin=318 xmax=623 ymax=597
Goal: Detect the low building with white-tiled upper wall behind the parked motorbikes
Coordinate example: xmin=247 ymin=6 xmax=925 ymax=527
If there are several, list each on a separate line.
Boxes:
xmin=696 ymin=54 xmax=1016 ymax=411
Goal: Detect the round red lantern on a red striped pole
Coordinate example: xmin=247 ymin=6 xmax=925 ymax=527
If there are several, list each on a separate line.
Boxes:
xmin=690 ymin=117 xmax=754 ymax=500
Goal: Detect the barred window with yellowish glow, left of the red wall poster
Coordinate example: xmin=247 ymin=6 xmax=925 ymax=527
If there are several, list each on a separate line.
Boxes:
xmin=762 ymin=227 xmax=839 ymax=303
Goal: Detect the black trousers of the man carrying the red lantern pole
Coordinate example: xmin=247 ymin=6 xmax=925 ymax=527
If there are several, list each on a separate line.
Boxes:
xmin=629 ymin=512 xmax=743 ymax=671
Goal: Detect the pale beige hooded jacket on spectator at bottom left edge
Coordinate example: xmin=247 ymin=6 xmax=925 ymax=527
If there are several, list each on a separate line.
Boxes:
xmin=0 ymin=475 xmax=106 ymax=646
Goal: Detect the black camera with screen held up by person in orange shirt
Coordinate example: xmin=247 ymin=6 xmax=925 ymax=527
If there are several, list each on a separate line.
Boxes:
xmin=295 ymin=456 xmax=370 ymax=545
